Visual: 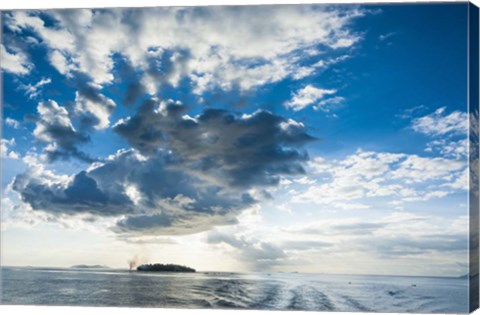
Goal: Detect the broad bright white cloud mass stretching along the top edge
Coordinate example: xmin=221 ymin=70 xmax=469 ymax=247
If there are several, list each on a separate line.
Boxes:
xmin=6 ymin=5 xmax=366 ymax=94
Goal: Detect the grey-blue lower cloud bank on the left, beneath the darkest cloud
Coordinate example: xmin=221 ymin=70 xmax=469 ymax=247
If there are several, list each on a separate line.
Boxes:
xmin=12 ymin=150 xmax=255 ymax=235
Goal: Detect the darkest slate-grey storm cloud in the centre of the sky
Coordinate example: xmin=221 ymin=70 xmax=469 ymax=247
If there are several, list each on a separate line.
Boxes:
xmin=113 ymin=100 xmax=313 ymax=188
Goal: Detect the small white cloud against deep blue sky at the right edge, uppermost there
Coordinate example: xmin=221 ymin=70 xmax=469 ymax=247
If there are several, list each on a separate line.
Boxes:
xmin=412 ymin=107 xmax=468 ymax=136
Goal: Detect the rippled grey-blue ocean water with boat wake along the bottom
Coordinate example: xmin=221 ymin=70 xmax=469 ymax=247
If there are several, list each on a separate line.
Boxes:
xmin=0 ymin=267 xmax=468 ymax=313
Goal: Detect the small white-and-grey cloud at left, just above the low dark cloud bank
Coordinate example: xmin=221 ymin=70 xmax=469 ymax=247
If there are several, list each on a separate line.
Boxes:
xmin=33 ymin=100 xmax=92 ymax=162
